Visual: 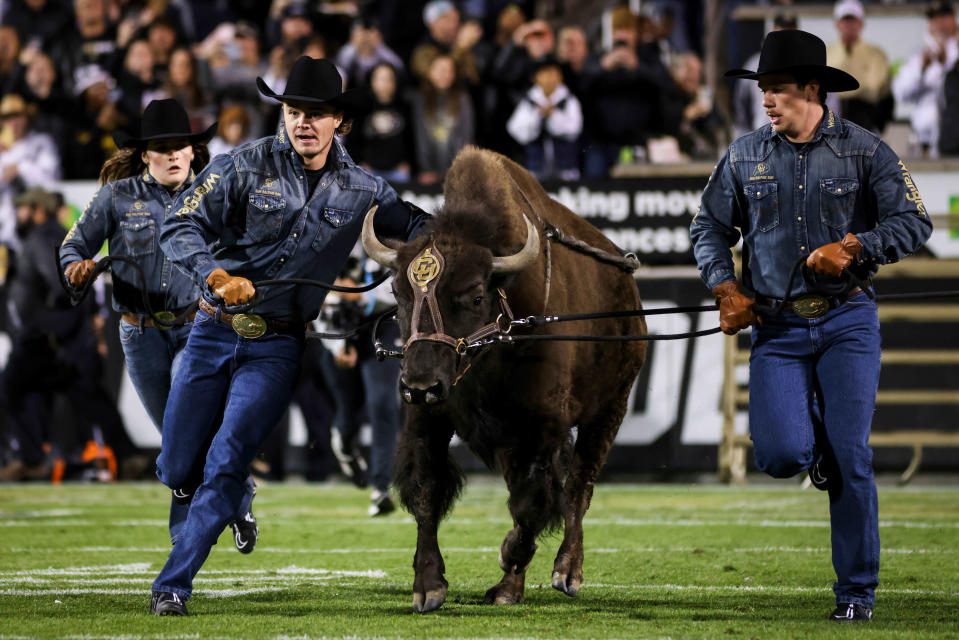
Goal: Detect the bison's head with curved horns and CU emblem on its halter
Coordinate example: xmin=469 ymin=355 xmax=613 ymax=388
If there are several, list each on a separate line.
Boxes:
xmin=362 ymin=209 xmax=540 ymax=404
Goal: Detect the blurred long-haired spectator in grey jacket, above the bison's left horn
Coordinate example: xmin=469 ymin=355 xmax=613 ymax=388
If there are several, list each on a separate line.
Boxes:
xmin=413 ymin=54 xmax=474 ymax=184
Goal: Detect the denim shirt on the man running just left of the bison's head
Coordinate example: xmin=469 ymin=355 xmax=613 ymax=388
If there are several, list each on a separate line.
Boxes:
xmin=160 ymin=128 xmax=429 ymax=324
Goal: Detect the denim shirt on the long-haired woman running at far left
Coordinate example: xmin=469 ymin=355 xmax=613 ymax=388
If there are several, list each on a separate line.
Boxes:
xmin=60 ymin=169 xmax=200 ymax=314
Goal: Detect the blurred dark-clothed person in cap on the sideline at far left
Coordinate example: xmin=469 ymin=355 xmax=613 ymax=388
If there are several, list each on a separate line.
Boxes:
xmin=0 ymin=188 xmax=144 ymax=481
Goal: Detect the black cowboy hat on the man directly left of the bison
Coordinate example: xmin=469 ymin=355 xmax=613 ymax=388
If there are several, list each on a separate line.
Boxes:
xmin=256 ymin=56 xmax=370 ymax=113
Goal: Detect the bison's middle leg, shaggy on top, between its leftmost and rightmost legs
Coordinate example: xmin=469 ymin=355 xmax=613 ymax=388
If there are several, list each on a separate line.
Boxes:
xmin=486 ymin=450 xmax=563 ymax=604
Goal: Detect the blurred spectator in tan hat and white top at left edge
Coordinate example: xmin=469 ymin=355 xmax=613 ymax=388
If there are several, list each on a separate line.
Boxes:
xmin=0 ymin=93 xmax=60 ymax=248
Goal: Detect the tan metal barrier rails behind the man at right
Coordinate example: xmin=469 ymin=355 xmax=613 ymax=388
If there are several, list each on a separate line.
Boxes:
xmin=719 ymin=257 xmax=959 ymax=484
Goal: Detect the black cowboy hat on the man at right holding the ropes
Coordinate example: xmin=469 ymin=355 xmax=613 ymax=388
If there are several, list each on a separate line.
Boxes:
xmin=725 ymin=29 xmax=859 ymax=92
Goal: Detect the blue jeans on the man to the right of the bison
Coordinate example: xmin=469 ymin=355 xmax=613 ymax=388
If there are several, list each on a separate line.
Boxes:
xmin=749 ymin=293 xmax=880 ymax=607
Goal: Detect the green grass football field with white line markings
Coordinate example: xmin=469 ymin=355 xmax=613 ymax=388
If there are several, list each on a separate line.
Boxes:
xmin=0 ymin=478 xmax=959 ymax=640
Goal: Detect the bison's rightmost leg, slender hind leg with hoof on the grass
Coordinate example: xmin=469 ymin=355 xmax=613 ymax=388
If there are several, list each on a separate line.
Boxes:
xmin=553 ymin=397 xmax=626 ymax=597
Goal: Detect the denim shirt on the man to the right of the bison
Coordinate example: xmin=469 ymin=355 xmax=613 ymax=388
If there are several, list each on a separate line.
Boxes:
xmin=690 ymin=109 xmax=932 ymax=298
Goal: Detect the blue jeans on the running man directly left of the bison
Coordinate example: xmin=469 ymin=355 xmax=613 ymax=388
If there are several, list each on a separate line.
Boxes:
xmin=153 ymin=311 xmax=303 ymax=599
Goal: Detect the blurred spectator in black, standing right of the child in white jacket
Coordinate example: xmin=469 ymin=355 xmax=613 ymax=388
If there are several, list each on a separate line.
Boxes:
xmin=583 ymin=7 xmax=677 ymax=178
